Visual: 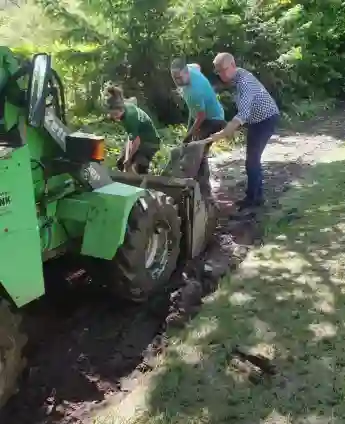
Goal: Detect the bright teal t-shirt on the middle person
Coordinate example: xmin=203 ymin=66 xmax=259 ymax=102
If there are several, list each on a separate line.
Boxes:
xmin=181 ymin=65 xmax=224 ymax=120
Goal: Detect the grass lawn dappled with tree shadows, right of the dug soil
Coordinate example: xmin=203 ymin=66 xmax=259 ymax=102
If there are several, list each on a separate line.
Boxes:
xmin=95 ymin=149 xmax=345 ymax=424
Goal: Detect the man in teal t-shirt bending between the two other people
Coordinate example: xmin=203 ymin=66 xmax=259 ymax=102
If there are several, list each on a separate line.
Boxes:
xmin=170 ymin=58 xmax=226 ymax=195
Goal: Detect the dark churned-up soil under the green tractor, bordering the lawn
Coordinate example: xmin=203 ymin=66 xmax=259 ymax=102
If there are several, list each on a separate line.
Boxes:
xmin=0 ymin=188 xmax=242 ymax=424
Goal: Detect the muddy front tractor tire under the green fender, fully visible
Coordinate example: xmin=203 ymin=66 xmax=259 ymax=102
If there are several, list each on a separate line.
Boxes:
xmin=106 ymin=191 xmax=181 ymax=303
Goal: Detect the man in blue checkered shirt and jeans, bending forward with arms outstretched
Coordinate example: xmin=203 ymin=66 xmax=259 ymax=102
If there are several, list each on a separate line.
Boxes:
xmin=208 ymin=53 xmax=280 ymax=210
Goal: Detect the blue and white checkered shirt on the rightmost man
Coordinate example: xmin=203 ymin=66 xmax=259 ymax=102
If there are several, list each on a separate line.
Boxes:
xmin=232 ymin=68 xmax=279 ymax=125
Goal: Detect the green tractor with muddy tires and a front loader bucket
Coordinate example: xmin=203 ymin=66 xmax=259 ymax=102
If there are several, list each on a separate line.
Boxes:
xmin=0 ymin=47 xmax=214 ymax=407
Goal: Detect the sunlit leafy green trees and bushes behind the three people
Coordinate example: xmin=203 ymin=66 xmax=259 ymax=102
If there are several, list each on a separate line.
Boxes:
xmin=0 ymin=0 xmax=345 ymax=172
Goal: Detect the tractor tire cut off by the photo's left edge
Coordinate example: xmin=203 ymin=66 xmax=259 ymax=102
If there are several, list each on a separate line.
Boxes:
xmin=0 ymin=299 xmax=27 ymax=408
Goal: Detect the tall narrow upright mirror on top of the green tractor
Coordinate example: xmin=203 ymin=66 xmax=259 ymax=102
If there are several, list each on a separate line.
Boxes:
xmin=28 ymin=53 xmax=51 ymax=128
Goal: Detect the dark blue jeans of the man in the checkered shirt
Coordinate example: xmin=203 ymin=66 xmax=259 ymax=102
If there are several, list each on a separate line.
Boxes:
xmin=246 ymin=115 xmax=279 ymax=201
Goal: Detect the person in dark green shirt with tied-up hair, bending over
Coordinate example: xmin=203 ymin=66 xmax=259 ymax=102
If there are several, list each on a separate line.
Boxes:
xmin=105 ymin=85 xmax=161 ymax=174
